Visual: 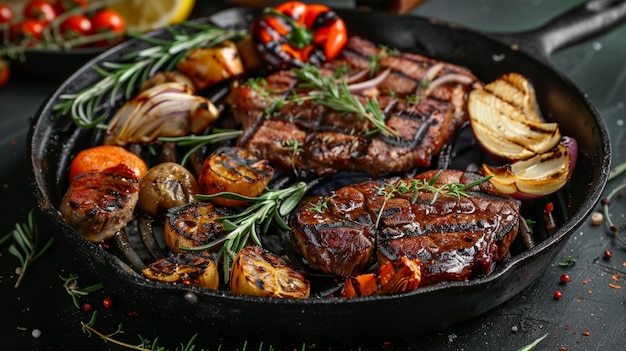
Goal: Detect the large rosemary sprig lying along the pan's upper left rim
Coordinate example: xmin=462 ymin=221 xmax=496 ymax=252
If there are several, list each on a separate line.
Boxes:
xmin=53 ymin=22 xmax=246 ymax=128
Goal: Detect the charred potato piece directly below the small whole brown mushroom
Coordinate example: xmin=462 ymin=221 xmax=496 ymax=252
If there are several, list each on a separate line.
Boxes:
xmin=163 ymin=202 xmax=231 ymax=252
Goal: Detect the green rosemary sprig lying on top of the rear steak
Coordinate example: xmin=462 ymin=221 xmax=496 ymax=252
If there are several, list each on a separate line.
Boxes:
xmin=293 ymin=65 xmax=398 ymax=136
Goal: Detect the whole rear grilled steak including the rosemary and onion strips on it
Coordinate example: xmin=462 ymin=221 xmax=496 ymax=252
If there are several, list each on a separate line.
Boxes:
xmin=227 ymin=38 xmax=476 ymax=175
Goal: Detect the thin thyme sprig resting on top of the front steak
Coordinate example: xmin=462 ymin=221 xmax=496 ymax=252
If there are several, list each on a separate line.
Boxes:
xmin=376 ymin=170 xmax=492 ymax=227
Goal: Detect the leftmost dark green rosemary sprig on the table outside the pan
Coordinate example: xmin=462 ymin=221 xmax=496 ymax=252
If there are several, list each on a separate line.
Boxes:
xmin=2 ymin=210 xmax=54 ymax=288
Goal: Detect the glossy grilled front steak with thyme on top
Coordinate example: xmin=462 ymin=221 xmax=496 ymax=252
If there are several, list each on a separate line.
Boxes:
xmin=290 ymin=170 xmax=521 ymax=286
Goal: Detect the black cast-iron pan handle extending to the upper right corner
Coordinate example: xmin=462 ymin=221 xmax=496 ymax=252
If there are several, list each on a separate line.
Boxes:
xmin=492 ymin=0 xmax=626 ymax=60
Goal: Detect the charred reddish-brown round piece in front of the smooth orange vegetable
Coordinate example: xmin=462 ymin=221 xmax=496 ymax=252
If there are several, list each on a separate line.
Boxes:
xmin=59 ymin=164 xmax=139 ymax=242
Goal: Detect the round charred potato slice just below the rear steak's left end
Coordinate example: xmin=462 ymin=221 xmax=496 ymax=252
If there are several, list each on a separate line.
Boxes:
xmin=198 ymin=147 xmax=274 ymax=206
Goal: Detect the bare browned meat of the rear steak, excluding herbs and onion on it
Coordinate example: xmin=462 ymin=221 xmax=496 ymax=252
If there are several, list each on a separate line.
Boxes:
xmin=227 ymin=37 xmax=476 ymax=175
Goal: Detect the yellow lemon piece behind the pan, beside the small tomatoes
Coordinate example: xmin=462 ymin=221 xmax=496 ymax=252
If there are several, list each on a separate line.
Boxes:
xmin=110 ymin=0 xmax=195 ymax=32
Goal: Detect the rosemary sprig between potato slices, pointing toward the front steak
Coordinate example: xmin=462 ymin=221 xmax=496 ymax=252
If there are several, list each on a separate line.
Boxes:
xmin=189 ymin=182 xmax=306 ymax=282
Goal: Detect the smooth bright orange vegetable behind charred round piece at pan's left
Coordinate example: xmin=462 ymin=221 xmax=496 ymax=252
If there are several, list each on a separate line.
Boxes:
xmin=70 ymin=145 xmax=148 ymax=182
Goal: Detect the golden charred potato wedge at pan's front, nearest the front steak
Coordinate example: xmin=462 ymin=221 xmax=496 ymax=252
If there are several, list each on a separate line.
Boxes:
xmin=230 ymin=245 xmax=311 ymax=299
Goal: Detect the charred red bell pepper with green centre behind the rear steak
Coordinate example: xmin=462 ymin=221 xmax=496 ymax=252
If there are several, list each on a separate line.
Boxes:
xmin=251 ymin=1 xmax=348 ymax=68
